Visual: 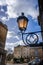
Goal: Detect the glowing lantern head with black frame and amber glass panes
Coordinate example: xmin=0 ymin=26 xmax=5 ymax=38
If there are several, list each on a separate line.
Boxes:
xmin=17 ymin=13 xmax=28 ymax=31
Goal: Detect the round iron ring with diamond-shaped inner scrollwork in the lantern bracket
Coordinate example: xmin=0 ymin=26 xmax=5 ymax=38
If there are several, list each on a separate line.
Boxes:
xmin=26 ymin=34 xmax=38 ymax=44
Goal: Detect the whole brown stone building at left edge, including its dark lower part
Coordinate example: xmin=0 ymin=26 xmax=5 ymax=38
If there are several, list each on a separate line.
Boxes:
xmin=0 ymin=22 xmax=8 ymax=65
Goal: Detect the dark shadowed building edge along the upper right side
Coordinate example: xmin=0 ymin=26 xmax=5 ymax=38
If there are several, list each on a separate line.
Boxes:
xmin=38 ymin=0 xmax=43 ymax=40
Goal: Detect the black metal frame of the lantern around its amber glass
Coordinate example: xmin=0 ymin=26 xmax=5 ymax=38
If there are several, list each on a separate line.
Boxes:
xmin=17 ymin=12 xmax=28 ymax=31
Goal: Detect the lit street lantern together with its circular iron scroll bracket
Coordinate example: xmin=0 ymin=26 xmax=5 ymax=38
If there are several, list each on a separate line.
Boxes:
xmin=17 ymin=13 xmax=38 ymax=45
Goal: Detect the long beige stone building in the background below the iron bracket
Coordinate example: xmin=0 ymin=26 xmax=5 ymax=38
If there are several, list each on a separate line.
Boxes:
xmin=14 ymin=46 xmax=43 ymax=60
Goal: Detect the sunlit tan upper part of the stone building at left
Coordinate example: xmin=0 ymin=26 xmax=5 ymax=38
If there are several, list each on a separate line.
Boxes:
xmin=0 ymin=22 xmax=8 ymax=48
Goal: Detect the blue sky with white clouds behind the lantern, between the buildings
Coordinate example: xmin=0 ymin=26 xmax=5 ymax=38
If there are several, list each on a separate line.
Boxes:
xmin=0 ymin=0 xmax=42 ymax=50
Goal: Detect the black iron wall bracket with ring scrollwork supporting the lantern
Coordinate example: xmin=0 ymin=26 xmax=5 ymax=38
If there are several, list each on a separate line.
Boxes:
xmin=22 ymin=31 xmax=43 ymax=45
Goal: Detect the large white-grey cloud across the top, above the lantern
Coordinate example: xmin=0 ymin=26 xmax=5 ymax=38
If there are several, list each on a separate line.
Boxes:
xmin=0 ymin=0 xmax=39 ymax=18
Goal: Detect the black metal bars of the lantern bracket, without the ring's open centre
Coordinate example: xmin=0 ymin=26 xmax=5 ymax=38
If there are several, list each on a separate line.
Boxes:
xmin=21 ymin=31 xmax=43 ymax=46
